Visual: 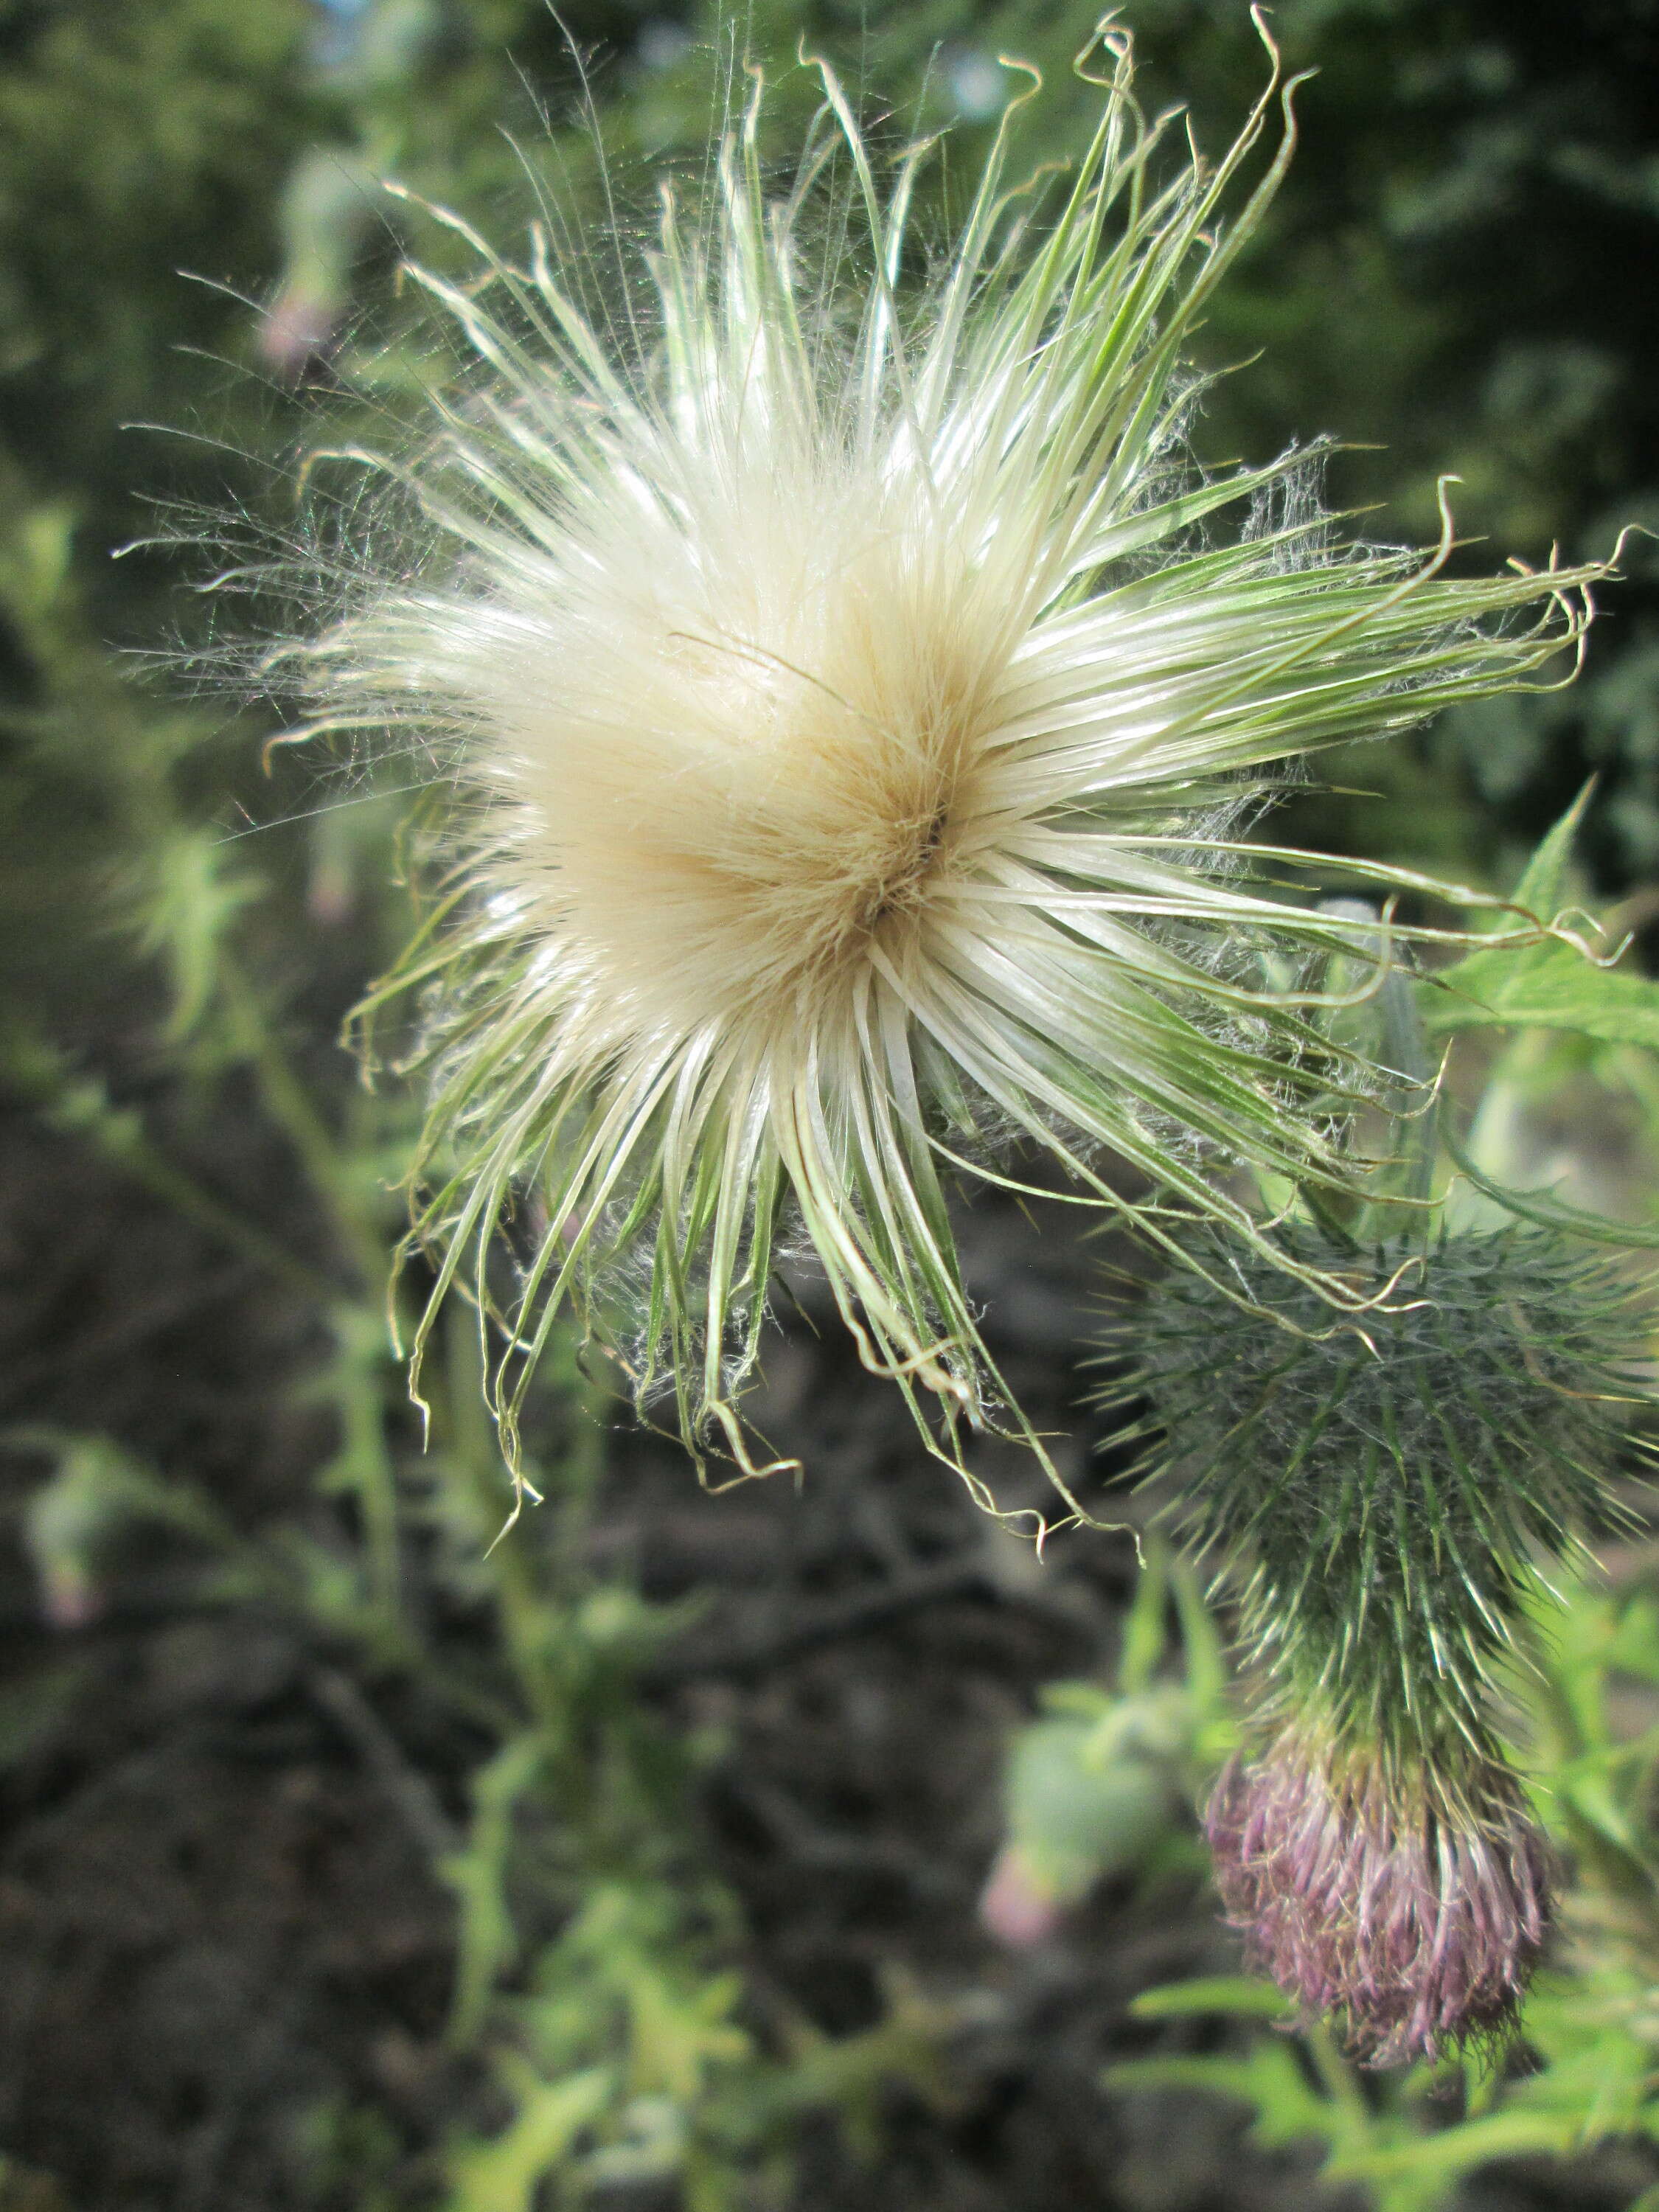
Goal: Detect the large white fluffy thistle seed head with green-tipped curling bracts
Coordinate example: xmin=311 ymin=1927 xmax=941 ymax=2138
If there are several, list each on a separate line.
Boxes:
xmin=274 ymin=22 xmax=1601 ymax=1511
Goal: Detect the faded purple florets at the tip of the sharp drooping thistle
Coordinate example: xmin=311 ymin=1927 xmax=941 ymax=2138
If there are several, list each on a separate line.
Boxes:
xmin=1206 ymin=1739 xmax=1551 ymax=2066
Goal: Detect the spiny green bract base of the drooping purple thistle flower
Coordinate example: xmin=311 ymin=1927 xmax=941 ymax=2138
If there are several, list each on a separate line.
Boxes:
xmin=1119 ymin=1228 xmax=1648 ymax=1787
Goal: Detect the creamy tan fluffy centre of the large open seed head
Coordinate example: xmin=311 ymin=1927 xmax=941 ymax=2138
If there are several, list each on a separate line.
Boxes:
xmin=471 ymin=460 xmax=1013 ymax=1057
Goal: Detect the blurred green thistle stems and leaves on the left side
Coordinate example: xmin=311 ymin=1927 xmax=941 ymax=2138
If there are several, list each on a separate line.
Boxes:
xmin=0 ymin=431 xmax=940 ymax=2212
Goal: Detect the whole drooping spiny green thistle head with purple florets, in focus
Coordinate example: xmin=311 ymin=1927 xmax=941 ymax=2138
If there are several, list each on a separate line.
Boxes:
xmin=1113 ymin=1228 xmax=1646 ymax=2064
